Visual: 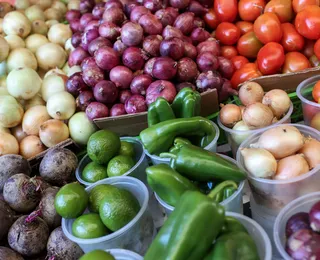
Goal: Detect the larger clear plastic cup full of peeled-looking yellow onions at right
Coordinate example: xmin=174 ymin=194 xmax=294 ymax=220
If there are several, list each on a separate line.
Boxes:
xmin=237 ymin=124 xmax=320 ymax=216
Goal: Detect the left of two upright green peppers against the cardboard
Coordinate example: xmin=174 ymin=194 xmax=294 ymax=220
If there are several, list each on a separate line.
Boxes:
xmin=148 ymin=97 xmax=175 ymax=127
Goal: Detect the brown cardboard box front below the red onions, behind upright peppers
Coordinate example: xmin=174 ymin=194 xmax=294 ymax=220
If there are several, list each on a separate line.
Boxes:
xmin=94 ymin=89 xmax=219 ymax=136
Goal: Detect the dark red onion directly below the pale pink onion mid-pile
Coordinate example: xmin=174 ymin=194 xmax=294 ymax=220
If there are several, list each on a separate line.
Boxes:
xmin=122 ymin=47 xmax=148 ymax=71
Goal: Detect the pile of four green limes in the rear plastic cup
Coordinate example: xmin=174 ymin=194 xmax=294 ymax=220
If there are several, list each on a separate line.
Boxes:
xmin=82 ymin=130 xmax=136 ymax=183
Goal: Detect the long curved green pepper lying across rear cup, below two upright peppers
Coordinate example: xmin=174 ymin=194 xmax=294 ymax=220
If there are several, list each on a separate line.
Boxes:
xmin=140 ymin=116 xmax=216 ymax=154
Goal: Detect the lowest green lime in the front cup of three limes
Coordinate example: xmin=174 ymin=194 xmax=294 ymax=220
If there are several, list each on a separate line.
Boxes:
xmin=72 ymin=213 xmax=109 ymax=239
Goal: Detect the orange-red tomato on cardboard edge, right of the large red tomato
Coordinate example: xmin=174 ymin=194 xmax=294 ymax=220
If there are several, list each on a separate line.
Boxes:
xmin=282 ymin=51 xmax=311 ymax=73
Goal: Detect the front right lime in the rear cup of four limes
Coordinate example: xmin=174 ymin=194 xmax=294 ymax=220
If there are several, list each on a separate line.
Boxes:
xmin=107 ymin=155 xmax=135 ymax=177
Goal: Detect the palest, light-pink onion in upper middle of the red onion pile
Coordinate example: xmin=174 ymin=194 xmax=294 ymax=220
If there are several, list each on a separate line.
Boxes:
xmin=121 ymin=22 xmax=143 ymax=46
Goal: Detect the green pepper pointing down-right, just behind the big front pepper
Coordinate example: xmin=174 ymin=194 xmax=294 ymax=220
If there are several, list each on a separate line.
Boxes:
xmin=146 ymin=164 xmax=198 ymax=207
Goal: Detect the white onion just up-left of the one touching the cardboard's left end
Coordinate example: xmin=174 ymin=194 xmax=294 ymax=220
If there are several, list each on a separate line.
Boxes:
xmin=47 ymin=91 xmax=76 ymax=120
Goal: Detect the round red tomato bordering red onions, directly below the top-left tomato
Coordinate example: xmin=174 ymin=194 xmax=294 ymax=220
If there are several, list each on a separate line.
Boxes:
xmin=216 ymin=22 xmax=240 ymax=45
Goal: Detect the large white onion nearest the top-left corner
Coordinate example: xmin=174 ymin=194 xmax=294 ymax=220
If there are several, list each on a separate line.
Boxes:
xmin=3 ymin=11 xmax=31 ymax=38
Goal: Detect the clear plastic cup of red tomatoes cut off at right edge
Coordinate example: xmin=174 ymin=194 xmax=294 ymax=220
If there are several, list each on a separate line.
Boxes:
xmin=297 ymin=75 xmax=320 ymax=130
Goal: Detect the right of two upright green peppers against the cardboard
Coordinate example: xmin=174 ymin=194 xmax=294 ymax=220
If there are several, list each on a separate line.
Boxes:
xmin=171 ymin=88 xmax=201 ymax=118
